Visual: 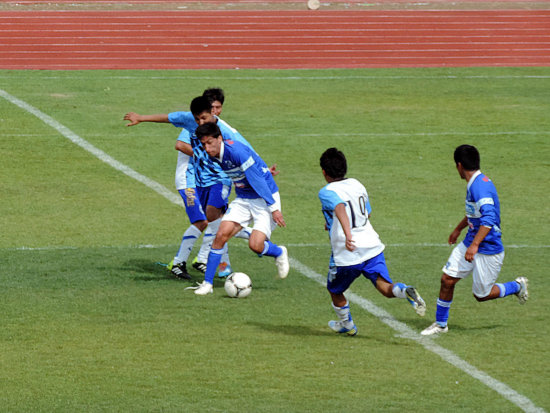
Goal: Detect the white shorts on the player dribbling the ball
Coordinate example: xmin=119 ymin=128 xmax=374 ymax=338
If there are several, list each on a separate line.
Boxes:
xmin=222 ymin=192 xmax=281 ymax=238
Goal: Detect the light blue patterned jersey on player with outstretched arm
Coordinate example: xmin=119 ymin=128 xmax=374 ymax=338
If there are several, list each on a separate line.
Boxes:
xmin=168 ymin=112 xmax=252 ymax=187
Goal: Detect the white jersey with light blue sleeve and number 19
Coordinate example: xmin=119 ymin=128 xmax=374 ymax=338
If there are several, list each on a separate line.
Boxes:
xmin=319 ymin=178 xmax=384 ymax=267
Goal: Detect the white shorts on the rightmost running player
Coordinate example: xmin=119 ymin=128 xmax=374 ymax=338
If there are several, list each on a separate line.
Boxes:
xmin=443 ymin=242 xmax=504 ymax=298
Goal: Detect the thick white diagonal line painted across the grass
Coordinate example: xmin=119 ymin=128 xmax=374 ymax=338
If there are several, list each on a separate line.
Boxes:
xmin=0 ymin=89 xmax=545 ymax=413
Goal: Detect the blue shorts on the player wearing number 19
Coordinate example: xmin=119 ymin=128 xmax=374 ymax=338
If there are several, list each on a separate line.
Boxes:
xmin=327 ymin=252 xmax=393 ymax=294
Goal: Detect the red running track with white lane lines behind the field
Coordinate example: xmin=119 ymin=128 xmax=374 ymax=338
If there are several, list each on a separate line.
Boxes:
xmin=0 ymin=10 xmax=550 ymax=69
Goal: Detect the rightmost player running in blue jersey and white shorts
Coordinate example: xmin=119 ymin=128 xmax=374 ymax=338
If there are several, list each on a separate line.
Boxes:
xmin=421 ymin=145 xmax=529 ymax=336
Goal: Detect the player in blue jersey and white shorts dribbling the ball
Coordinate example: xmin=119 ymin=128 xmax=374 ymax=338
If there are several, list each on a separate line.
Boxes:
xmin=190 ymin=123 xmax=289 ymax=295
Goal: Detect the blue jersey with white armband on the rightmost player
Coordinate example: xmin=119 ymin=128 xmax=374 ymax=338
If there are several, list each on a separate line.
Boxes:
xmin=463 ymin=171 xmax=504 ymax=255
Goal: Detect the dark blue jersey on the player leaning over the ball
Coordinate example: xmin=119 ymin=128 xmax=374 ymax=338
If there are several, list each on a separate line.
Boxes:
xmin=211 ymin=140 xmax=279 ymax=208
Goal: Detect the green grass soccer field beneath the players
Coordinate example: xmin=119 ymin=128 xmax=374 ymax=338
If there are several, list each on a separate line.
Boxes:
xmin=0 ymin=68 xmax=550 ymax=412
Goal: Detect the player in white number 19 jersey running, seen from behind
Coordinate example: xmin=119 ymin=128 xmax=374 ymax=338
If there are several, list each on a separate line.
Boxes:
xmin=319 ymin=148 xmax=426 ymax=336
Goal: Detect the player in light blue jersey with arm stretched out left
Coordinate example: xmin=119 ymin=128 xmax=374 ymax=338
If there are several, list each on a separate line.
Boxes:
xmin=124 ymin=96 xmax=251 ymax=278
